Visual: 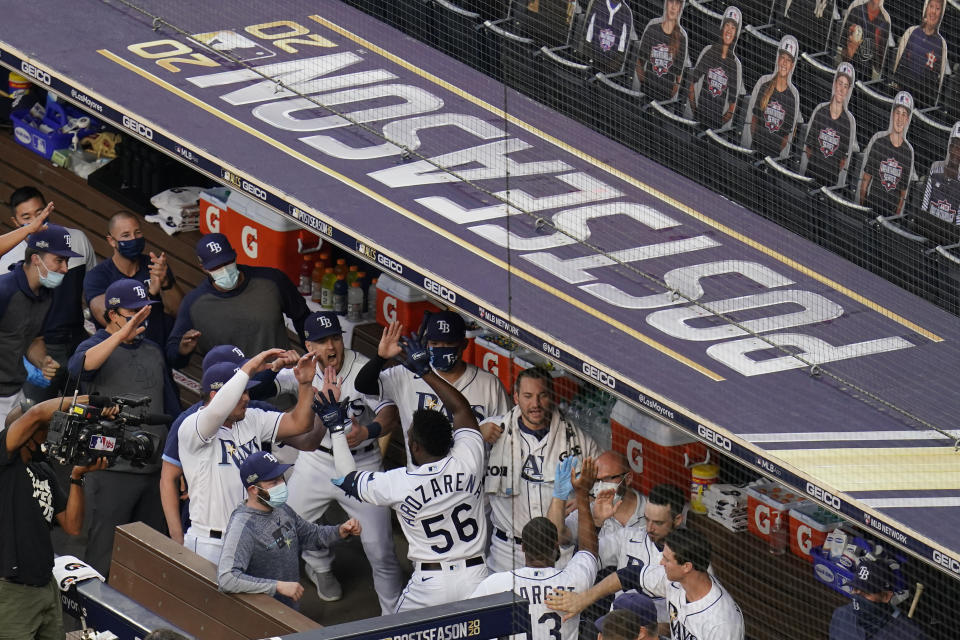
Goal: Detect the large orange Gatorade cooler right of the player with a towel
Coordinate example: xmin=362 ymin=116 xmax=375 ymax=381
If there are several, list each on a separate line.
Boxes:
xmin=610 ymin=400 xmax=709 ymax=495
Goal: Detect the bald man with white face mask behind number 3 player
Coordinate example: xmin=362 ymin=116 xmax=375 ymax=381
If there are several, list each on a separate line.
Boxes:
xmin=561 ymin=450 xmax=647 ymax=567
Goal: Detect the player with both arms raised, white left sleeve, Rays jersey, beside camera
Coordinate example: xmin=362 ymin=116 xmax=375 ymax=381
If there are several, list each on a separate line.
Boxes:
xmin=179 ymin=349 xmax=315 ymax=564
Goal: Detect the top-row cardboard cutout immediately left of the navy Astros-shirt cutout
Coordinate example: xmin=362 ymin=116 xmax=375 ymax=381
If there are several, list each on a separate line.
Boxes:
xmin=838 ymin=0 xmax=890 ymax=82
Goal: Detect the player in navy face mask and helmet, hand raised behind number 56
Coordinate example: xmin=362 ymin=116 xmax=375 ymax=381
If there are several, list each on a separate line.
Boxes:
xmin=354 ymin=311 xmax=510 ymax=470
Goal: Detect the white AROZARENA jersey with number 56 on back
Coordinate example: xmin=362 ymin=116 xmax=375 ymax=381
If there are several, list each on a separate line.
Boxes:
xmin=357 ymin=429 xmax=487 ymax=562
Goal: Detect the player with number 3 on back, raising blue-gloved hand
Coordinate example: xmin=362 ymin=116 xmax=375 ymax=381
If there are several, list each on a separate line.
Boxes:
xmin=473 ymin=457 xmax=600 ymax=640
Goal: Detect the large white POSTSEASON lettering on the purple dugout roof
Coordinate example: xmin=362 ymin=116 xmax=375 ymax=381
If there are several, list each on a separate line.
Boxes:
xmin=165 ymin=22 xmax=914 ymax=376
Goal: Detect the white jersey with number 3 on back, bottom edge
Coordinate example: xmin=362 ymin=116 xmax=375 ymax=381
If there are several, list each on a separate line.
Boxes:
xmin=473 ymin=551 xmax=600 ymax=640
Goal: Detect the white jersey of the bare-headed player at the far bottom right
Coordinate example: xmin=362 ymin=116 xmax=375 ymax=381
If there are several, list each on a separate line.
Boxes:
xmin=643 ymin=566 xmax=744 ymax=640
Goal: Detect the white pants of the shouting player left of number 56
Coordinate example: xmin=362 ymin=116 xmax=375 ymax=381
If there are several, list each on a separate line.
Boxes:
xmin=287 ymin=442 xmax=403 ymax=615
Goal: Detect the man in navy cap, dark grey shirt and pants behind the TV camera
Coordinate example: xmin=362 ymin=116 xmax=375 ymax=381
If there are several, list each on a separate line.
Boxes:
xmin=67 ymin=279 xmax=179 ymax=576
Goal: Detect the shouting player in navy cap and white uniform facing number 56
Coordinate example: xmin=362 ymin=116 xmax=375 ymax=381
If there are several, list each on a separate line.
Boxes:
xmin=277 ymin=311 xmax=403 ymax=615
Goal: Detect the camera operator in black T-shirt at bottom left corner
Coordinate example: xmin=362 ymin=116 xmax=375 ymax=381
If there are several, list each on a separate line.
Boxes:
xmin=0 ymin=397 xmax=109 ymax=639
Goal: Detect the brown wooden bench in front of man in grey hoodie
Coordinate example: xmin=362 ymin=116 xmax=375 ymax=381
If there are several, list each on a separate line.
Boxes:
xmin=109 ymin=522 xmax=321 ymax=640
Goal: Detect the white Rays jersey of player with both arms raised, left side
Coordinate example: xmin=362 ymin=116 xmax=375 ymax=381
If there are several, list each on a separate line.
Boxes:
xmin=179 ymin=407 xmax=283 ymax=531
